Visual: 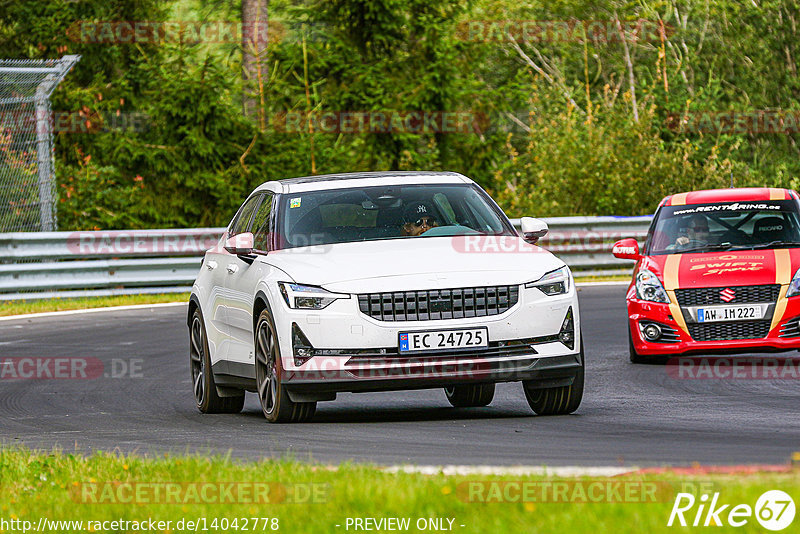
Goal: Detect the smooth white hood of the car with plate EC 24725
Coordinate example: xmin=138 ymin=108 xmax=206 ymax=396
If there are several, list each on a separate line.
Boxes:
xmin=263 ymin=236 xmax=564 ymax=293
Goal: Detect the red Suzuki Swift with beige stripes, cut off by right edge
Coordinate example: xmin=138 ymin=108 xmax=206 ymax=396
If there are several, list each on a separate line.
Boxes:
xmin=613 ymin=188 xmax=800 ymax=363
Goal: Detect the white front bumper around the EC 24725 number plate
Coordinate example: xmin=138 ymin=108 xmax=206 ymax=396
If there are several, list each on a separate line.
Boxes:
xmin=273 ymin=285 xmax=583 ymax=398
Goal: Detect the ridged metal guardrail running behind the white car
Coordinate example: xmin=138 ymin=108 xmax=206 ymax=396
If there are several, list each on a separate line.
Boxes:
xmin=0 ymin=216 xmax=651 ymax=301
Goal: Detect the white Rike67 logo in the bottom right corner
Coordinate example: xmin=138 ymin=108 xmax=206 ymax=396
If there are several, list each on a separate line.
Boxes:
xmin=667 ymin=490 xmax=795 ymax=531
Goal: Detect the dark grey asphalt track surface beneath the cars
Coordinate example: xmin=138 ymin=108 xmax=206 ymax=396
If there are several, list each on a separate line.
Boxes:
xmin=0 ymin=286 xmax=800 ymax=467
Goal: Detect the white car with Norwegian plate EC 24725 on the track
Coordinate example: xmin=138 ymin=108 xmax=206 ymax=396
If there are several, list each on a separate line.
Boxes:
xmin=188 ymin=172 xmax=584 ymax=422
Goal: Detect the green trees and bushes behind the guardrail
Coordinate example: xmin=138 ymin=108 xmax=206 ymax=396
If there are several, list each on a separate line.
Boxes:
xmin=0 ymin=0 xmax=800 ymax=230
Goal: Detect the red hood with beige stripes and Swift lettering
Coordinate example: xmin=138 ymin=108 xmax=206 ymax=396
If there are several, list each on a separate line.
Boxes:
xmin=640 ymin=249 xmax=800 ymax=291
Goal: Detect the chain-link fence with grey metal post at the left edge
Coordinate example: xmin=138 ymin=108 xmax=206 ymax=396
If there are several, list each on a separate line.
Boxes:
xmin=0 ymin=56 xmax=80 ymax=232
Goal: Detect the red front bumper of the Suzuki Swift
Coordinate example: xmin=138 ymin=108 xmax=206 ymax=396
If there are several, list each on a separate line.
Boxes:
xmin=627 ymin=291 xmax=800 ymax=356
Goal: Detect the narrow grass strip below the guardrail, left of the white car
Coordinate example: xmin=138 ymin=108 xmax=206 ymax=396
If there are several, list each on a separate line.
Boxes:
xmin=0 ymin=293 xmax=189 ymax=317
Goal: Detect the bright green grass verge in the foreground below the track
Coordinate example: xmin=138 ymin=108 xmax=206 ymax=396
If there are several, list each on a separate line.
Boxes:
xmin=0 ymin=447 xmax=800 ymax=534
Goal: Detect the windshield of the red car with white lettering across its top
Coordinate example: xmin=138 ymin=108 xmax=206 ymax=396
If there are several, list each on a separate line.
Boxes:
xmin=645 ymin=200 xmax=800 ymax=255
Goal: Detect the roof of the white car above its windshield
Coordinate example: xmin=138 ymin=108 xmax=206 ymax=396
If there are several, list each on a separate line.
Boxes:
xmin=256 ymin=171 xmax=473 ymax=194
